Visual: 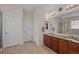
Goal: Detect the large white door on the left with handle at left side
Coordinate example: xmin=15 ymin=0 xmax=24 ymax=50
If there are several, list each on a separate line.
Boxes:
xmin=3 ymin=15 xmax=19 ymax=47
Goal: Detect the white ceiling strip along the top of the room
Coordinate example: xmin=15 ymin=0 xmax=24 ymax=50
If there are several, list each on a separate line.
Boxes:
xmin=17 ymin=4 xmax=56 ymax=11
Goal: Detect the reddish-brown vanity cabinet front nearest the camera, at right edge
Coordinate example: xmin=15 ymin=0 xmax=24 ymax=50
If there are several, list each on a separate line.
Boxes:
xmin=68 ymin=41 xmax=79 ymax=54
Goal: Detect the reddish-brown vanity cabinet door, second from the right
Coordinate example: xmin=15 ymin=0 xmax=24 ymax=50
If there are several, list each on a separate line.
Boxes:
xmin=58 ymin=39 xmax=67 ymax=54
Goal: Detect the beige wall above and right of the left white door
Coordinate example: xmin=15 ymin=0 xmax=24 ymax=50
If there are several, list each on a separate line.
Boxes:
xmin=0 ymin=5 xmax=23 ymax=44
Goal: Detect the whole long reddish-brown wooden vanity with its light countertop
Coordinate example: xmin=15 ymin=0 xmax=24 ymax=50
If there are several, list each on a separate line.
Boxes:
xmin=43 ymin=33 xmax=79 ymax=54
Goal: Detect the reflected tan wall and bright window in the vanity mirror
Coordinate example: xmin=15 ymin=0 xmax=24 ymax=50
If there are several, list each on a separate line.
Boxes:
xmin=57 ymin=18 xmax=79 ymax=35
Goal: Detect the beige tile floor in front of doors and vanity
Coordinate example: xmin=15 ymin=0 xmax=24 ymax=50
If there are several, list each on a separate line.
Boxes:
xmin=0 ymin=42 xmax=56 ymax=54
